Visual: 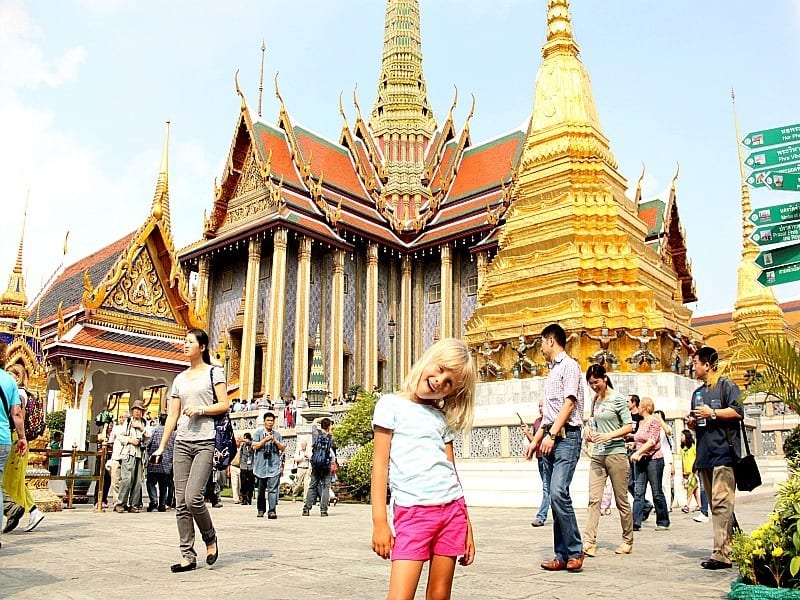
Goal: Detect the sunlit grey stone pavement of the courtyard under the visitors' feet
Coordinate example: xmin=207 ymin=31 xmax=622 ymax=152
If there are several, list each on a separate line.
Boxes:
xmin=0 ymin=487 xmax=774 ymax=600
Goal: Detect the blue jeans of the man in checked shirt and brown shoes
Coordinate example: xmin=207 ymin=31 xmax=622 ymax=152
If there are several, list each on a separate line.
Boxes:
xmin=542 ymin=431 xmax=583 ymax=562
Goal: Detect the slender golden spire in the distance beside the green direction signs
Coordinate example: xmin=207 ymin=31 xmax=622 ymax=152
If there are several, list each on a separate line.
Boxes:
xmin=731 ymin=90 xmax=786 ymax=383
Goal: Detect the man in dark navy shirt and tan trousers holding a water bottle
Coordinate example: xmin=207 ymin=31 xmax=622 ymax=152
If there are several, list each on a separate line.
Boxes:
xmin=686 ymin=346 xmax=743 ymax=570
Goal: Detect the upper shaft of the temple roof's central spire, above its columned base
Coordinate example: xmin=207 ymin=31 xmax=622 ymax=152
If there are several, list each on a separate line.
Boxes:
xmin=369 ymin=0 xmax=436 ymax=139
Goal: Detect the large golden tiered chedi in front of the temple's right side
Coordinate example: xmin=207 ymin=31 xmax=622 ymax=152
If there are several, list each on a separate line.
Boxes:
xmin=467 ymin=0 xmax=699 ymax=359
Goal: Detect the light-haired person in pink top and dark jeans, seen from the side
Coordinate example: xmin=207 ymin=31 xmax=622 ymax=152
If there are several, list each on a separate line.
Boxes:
xmin=631 ymin=398 xmax=670 ymax=531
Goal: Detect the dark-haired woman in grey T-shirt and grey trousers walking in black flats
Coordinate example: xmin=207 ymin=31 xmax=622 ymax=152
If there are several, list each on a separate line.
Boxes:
xmin=151 ymin=329 xmax=228 ymax=573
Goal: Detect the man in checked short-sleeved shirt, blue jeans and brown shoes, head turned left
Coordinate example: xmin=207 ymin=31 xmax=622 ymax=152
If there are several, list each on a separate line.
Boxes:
xmin=525 ymin=323 xmax=584 ymax=571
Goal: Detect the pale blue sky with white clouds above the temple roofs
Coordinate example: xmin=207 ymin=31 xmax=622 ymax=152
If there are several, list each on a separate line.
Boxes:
xmin=0 ymin=0 xmax=800 ymax=314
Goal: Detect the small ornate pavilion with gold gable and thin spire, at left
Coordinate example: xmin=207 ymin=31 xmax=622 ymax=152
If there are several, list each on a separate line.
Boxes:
xmin=23 ymin=123 xmax=202 ymax=448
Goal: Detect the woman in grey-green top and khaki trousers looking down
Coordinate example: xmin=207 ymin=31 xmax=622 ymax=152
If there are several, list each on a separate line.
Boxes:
xmin=583 ymin=364 xmax=633 ymax=556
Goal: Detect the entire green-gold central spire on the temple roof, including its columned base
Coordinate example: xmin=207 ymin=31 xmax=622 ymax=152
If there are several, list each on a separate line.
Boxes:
xmin=369 ymin=0 xmax=437 ymax=230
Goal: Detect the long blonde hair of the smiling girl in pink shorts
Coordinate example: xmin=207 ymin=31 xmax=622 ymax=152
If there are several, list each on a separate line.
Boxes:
xmin=400 ymin=338 xmax=477 ymax=431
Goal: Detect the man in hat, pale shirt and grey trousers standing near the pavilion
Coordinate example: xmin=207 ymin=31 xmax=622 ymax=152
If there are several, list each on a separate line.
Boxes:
xmin=114 ymin=399 xmax=150 ymax=512
